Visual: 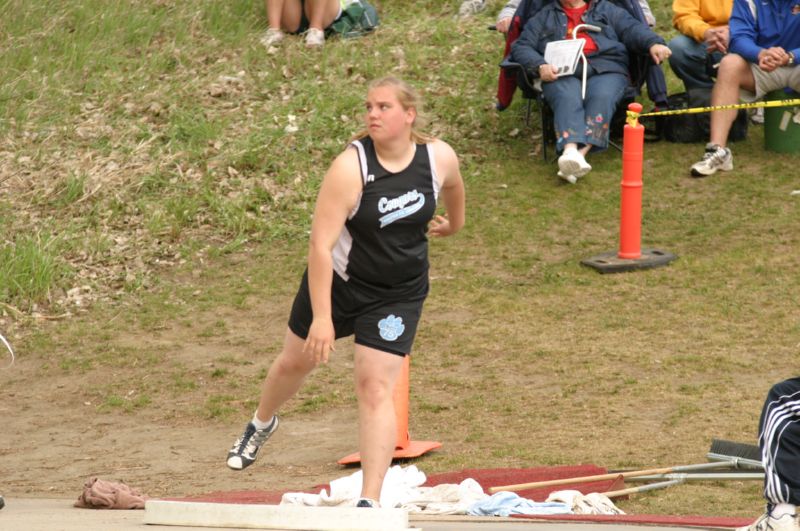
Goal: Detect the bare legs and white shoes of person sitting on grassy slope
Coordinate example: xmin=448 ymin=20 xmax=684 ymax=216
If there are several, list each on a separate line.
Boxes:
xmin=261 ymin=0 xmax=342 ymax=47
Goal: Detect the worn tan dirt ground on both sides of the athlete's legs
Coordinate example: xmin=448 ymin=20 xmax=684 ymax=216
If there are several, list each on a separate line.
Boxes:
xmin=0 ymin=270 xmax=772 ymax=516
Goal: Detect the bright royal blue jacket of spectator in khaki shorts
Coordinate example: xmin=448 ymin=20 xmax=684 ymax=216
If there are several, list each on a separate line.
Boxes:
xmin=728 ymin=0 xmax=800 ymax=67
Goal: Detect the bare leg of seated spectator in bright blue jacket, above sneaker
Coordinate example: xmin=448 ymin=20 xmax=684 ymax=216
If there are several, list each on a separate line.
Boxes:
xmin=710 ymin=53 xmax=756 ymax=147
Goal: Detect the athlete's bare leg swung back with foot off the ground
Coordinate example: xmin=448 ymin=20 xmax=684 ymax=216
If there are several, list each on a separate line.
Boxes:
xmin=256 ymin=330 xmax=316 ymax=422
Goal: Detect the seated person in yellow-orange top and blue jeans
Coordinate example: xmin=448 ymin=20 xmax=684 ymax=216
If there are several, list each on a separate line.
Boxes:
xmin=669 ymin=0 xmax=733 ymax=92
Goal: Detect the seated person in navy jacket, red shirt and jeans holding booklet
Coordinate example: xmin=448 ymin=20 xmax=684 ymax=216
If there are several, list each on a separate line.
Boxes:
xmin=511 ymin=0 xmax=670 ymax=183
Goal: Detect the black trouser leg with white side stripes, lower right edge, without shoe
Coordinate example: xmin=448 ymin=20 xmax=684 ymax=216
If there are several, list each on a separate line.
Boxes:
xmin=759 ymin=378 xmax=800 ymax=505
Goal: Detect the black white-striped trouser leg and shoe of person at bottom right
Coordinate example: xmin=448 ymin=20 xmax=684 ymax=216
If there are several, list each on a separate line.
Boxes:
xmin=737 ymin=378 xmax=800 ymax=531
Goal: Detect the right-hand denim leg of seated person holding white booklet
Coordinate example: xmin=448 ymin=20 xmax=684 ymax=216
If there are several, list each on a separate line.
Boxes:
xmin=583 ymin=73 xmax=628 ymax=149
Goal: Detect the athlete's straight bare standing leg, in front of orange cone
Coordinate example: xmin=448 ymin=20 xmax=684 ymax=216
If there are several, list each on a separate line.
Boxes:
xmin=355 ymin=345 xmax=403 ymax=500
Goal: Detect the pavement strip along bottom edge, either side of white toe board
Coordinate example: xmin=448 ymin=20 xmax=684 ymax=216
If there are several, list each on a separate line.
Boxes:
xmin=0 ymin=498 xmax=712 ymax=531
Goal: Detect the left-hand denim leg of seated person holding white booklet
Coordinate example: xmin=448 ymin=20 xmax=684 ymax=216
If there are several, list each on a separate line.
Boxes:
xmin=542 ymin=76 xmax=588 ymax=151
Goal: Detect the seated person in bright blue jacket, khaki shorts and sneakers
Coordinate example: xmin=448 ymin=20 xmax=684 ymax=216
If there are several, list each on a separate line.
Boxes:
xmin=691 ymin=0 xmax=800 ymax=177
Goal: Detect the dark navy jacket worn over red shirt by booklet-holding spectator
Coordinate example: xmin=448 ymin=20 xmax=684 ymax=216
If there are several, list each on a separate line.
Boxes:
xmin=511 ymin=0 xmax=664 ymax=77
